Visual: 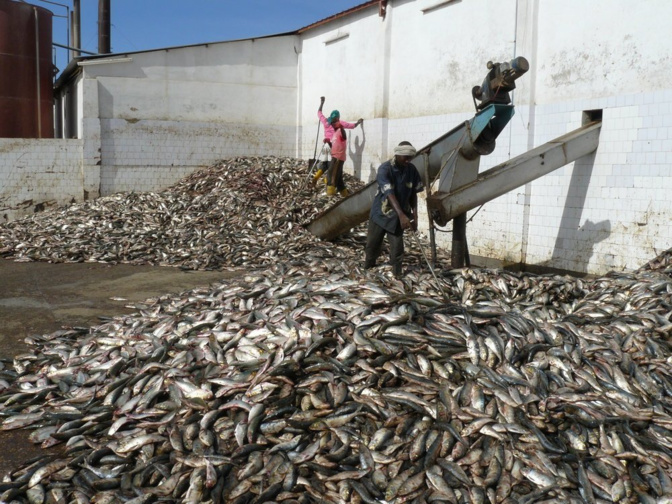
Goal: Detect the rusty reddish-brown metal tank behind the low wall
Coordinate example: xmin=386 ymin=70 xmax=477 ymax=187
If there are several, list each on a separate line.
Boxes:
xmin=0 ymin=0 xmax=54 ymax=138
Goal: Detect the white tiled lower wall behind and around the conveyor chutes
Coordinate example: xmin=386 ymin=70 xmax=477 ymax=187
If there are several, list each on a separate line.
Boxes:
xmin=390 ymin=90 xmax=672 ymax=273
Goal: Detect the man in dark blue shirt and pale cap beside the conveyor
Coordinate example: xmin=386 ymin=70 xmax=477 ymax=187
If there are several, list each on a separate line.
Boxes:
xmin=364 ymin=142 xmax=424 ymax=278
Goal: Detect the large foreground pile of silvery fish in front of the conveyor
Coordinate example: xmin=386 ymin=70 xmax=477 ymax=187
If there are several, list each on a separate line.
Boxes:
xmin=0 ymin=156 xmax=672 ymax=503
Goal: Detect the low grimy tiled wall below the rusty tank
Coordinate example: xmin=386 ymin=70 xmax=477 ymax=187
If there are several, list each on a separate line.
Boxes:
xmin=0 ymin=138 xmax=84 ymax=222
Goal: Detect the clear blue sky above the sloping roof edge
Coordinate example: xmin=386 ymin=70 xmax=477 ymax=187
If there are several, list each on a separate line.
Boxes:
xmin=38 ymin=0 xmax=365 ymax=74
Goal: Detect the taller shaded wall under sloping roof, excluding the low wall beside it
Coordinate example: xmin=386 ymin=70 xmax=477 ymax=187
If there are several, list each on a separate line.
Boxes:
xmin=83 ymin=36 xmax=297 ymax=195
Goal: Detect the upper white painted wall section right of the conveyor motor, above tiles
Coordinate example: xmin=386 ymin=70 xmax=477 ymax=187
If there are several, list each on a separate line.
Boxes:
xmin=536 ymin=0 xmax=672 ymax=104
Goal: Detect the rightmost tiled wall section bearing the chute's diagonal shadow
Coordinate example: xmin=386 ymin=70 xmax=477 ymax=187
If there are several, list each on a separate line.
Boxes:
xmin=528 ymin=91 xmax=672 ymax=273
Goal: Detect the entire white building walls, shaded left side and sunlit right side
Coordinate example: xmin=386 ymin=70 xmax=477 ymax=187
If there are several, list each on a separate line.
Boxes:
xmin=0 ymin=0 xmax=672 ymax=273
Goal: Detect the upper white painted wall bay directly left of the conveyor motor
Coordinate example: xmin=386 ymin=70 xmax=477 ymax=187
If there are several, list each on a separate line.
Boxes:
xmin=388 ymin=0 xmax=516 ymax=117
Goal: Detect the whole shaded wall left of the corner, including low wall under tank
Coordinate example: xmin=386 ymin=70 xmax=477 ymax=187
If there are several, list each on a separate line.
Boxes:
xmin=0 ymin=36 xmax=298 ymax=220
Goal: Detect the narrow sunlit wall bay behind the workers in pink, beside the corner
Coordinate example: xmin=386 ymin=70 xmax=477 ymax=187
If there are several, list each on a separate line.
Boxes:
xmin=298 ymin=6 xmax=390 ymax=179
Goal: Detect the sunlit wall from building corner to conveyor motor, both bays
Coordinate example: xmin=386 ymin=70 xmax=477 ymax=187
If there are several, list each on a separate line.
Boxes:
xmin=299 ymin=0 xmax=516 ymax=180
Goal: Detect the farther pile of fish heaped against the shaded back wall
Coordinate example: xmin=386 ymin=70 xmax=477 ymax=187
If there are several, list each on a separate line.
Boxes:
xmin=0 ymin=157 xmax=363 ymax=269
